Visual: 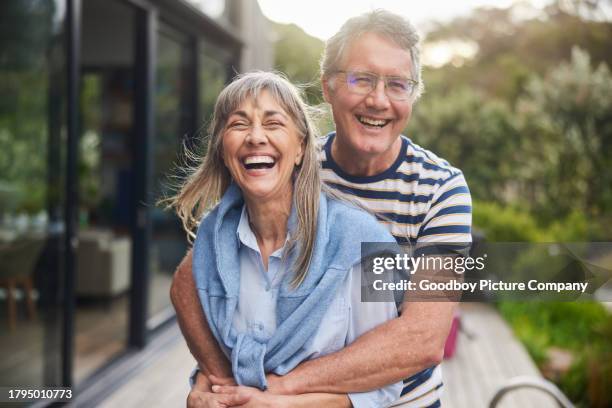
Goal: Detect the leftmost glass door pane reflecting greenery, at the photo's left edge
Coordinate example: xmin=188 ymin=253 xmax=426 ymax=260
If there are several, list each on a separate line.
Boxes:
xmin=0 ymin=0 xmax=67 ymax=388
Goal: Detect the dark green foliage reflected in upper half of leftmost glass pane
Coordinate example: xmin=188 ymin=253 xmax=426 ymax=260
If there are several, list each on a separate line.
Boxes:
xmin=0 ymin=0 xmax=64 ymax=214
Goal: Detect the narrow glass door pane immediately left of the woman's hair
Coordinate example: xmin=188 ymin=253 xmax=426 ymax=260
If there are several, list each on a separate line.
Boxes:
xmin=148 ymin=23 xmax=194 ymax=328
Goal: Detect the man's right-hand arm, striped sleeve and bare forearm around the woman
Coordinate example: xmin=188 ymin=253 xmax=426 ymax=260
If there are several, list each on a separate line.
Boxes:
xmin=268 ymin=172 xmax=472 ymax=394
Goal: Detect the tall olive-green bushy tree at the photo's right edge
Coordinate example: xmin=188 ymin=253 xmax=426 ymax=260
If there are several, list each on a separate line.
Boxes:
xmin=518 ymin=47 xmax=612 ymax=216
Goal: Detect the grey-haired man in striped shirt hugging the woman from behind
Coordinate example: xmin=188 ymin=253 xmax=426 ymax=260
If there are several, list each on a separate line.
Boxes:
xmin=171 ymin=10 xmax=471 ymax=407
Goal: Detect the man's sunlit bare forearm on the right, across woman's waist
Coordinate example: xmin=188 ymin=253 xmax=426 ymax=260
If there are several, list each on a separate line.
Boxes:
xmin=268 ymin=302 xmax=456 ymax=394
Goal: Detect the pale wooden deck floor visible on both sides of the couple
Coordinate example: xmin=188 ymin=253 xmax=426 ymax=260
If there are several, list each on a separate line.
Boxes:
xmin=101 ymin=303 xmax=557 ymax=408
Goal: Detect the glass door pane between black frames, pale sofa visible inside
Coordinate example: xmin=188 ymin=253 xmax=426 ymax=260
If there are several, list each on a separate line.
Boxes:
xmin=74 ymin=0 xmax=137 ymax=383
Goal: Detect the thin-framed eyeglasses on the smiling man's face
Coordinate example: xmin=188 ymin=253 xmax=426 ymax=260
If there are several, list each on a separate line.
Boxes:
xmin=336 ymin=71 xmax=419 ymax=101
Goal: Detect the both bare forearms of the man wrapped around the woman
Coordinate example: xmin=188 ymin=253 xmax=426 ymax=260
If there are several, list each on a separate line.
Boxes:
xmin=171 ymin=253 xmax=455 ymax=394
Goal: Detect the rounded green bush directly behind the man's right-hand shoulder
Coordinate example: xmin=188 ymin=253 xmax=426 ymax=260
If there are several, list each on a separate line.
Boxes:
xmin=412 ymin=87 xmax=522 ymax=202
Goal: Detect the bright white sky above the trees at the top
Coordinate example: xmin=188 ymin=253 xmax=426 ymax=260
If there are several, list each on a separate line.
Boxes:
xmin=258 ymin=0 xmax=549 ymax=40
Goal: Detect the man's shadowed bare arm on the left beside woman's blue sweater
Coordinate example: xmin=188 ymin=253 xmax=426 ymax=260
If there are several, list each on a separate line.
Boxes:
xmin=170 ymin=251 xmax=232 ymax=377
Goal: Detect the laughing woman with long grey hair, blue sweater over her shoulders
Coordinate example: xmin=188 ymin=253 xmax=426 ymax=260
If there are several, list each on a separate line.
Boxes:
xmin=173 ymin=72 xmax=401 ymax=407
